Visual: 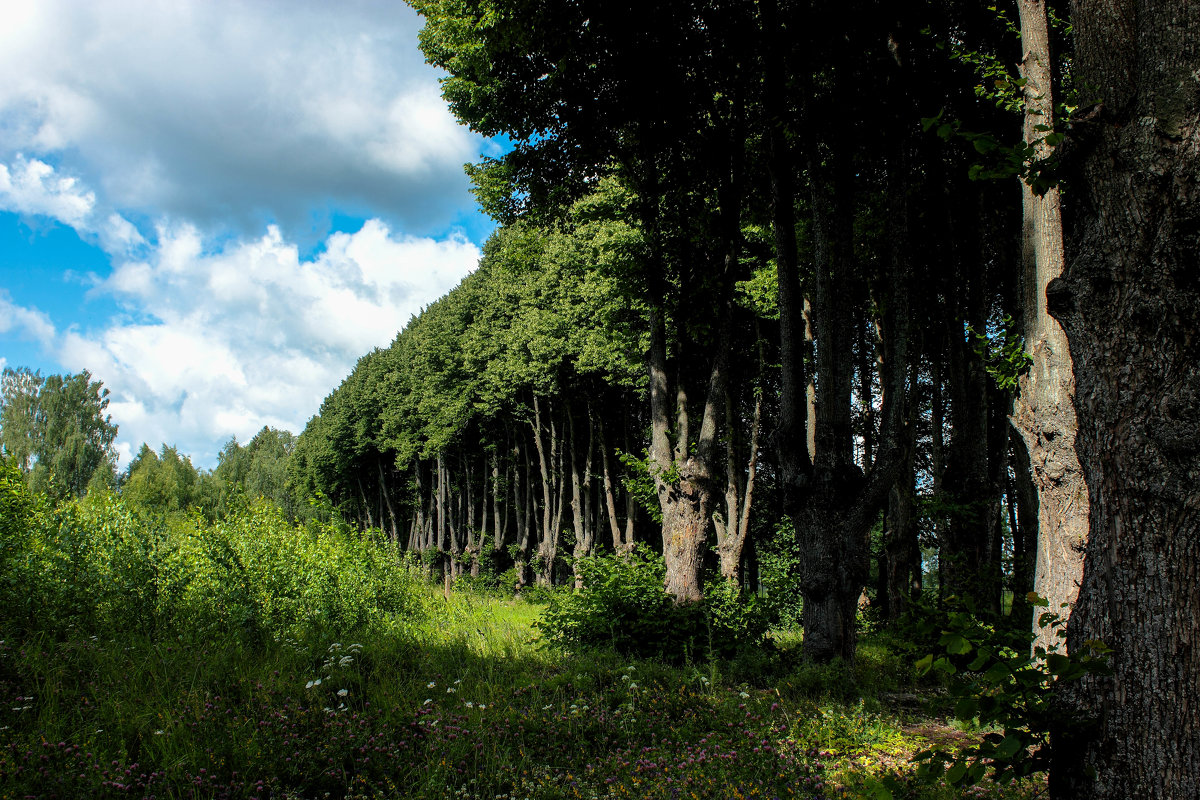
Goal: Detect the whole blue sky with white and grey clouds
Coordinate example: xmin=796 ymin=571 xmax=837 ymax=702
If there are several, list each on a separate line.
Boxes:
xmin=0 ymin=0 xmax=502 ymax=468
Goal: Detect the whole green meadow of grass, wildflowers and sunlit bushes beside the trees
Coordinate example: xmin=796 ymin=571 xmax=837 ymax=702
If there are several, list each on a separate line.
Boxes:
xmin=0 ymin=470 xmax=1041 ymax=800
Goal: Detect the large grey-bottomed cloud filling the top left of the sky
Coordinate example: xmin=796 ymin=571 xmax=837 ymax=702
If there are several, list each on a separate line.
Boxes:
xmin=0 ymin=0 xmax=487 ymax=239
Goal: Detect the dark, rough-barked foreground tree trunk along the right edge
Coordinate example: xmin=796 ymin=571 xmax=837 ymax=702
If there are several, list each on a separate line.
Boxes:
xmin=1046 ymin=0 xmax=1200 ymax=800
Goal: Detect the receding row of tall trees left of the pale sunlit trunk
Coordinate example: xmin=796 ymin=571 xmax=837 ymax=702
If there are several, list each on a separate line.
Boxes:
xmin=302 ymin=2 xmax=1051 ymax=638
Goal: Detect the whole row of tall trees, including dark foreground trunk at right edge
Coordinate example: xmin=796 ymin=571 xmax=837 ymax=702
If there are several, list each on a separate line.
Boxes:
xmin=294 ymin=0 xmax=1200 ymax=798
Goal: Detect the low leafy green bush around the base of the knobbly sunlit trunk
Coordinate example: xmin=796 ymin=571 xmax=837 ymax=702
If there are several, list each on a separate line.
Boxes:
xmin=539 ymin=545 xmax=767 ymax=662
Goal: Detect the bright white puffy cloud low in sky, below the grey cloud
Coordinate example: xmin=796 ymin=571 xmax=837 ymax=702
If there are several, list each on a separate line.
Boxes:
xmin=56 ymin=219 xmax=479 ymax=465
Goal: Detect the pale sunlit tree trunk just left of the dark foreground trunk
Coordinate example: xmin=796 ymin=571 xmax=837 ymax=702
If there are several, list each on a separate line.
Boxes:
xmin=1012 ymin=0 xmax=1087 ymax=650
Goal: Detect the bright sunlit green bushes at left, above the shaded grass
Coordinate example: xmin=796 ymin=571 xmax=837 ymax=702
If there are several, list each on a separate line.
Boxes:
xmin=0 ymin=489 xmax=420 ymax=640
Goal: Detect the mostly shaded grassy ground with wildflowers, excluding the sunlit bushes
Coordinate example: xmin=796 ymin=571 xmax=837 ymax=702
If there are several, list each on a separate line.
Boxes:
xmin=0 ymin=594 xmax=1042 ymax=800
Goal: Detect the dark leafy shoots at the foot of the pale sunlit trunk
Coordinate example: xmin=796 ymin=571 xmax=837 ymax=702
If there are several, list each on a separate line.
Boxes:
xmin=914 ymin=593 xmax=1109 ymax=786
